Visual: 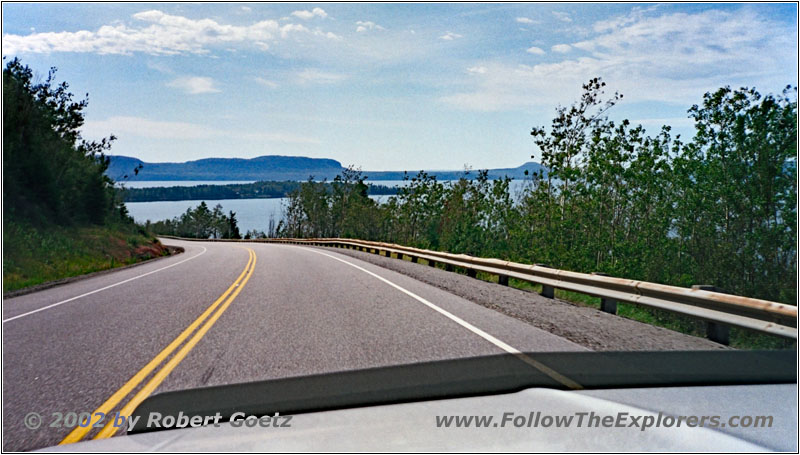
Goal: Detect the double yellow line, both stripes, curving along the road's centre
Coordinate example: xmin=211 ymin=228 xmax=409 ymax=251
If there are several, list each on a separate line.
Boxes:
xmin=60 ymin=248 xmax=256 ymax=444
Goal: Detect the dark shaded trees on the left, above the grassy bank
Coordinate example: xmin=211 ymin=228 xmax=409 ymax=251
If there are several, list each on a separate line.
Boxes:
xmin=3 ymin=59 xmax=132 ymax=226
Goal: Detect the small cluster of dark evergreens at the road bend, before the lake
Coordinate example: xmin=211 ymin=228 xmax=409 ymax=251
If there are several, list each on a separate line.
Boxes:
xmin=145 ymin=201 xmax=242 ymax=239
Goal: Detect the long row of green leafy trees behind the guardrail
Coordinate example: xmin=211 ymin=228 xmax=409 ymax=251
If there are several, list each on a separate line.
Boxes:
xmin=279 ymin=79 xmax=797 ymax=304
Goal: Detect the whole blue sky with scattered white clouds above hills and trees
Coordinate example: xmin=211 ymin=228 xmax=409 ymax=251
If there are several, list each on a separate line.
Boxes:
xmin=2 ymin=3 xmax=798 ymax=170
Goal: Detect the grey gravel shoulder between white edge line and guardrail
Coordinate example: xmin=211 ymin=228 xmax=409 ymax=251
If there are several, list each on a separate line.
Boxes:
xmin=321 ymin=248 xmax=730 ymax=351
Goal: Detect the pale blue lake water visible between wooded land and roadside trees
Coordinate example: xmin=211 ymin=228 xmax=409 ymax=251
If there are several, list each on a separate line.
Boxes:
xmin=125 ymin=180 xmax=526 ymax=234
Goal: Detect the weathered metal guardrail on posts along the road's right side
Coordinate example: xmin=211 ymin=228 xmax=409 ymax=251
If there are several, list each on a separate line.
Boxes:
xmin=164 ymin=236 xmax=797 ymax=344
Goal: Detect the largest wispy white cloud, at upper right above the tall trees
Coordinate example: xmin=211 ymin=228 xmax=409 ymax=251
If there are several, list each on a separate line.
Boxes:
xmin=440 ymin=8 xmax=798 ymax=111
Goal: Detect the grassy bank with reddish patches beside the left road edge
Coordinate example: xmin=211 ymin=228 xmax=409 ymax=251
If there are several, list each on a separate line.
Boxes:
xmin=3 ymin=222 xmax=167 ymax=293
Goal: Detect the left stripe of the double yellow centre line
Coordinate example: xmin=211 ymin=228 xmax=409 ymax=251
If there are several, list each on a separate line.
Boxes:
xmin=59 ymin=248 xmax=256 ymax=444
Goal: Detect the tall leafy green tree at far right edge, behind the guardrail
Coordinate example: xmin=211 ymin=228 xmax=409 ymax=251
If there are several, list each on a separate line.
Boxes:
xmin=676 ymin=86 xmax=797 ymax=301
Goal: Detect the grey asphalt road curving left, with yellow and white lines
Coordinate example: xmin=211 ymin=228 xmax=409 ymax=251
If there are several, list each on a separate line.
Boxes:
xmin=3 ymin=239 xmax=585 ymax=450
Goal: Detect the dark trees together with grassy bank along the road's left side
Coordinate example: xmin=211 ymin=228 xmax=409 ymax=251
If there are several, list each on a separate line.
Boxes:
xmin=3 ymin=59 xmax=166 ymax=292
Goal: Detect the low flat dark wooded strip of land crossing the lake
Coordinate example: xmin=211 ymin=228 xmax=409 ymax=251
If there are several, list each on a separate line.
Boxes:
xmin=120 ymin=181 xmax=397 ymax=202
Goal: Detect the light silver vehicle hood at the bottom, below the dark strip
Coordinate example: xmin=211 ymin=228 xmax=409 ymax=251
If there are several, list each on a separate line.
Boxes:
xmin=44 ymin=384 xmax=797 ymax=452
